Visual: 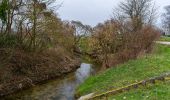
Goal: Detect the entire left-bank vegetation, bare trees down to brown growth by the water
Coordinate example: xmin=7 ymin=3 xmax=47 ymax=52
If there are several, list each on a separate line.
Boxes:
xmin=0 ymin=0 xmax=80 ymax=95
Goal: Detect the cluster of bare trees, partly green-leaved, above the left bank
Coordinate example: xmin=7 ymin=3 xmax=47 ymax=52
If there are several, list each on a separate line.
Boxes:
xmin=0 ymin=0 xmax=59 ymax=50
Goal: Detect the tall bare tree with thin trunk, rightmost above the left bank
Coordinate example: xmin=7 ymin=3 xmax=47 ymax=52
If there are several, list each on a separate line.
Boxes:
xmin=22 ymin=0 xmax=55 ymax=50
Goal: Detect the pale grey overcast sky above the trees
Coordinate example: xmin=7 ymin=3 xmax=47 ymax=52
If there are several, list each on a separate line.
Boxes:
xmin=57 ymin=0 xmax=170 ymax=26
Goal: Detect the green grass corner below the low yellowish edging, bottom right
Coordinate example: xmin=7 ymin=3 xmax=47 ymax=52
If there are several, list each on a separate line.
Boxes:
xmin=109 ymin=81 xmax=170 ymax=100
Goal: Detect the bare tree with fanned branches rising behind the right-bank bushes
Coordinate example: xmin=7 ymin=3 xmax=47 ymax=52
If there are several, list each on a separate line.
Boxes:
xmin=114 ymin=0 xmax=156 ymax=31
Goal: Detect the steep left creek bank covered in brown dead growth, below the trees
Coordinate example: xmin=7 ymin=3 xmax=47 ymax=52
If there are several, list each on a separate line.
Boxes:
xmin=0 ymin=49 xmax=80 ymax=97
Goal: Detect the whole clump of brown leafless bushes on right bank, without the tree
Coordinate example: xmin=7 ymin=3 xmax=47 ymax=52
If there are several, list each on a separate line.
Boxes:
xmin=90 ymin=20 xmax=159 ymax=68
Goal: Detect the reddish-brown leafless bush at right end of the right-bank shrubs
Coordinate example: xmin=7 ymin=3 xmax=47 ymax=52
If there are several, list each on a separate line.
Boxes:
xmin=116 ymin=26 xmax=159 ymax=63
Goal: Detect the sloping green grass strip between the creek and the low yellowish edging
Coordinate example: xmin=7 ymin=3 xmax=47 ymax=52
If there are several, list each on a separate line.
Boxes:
xmin=76 ymin=45 xmax=170 ymax=95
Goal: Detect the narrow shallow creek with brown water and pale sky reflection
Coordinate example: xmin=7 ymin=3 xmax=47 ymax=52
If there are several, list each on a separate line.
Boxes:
xmin=4 ymin=63 xmax=95 ymax=100
